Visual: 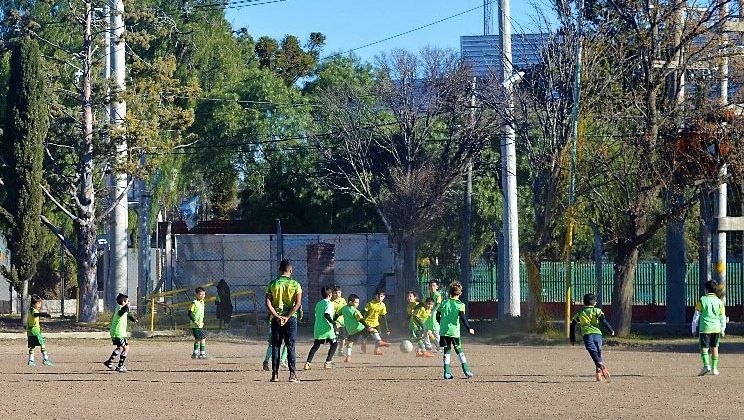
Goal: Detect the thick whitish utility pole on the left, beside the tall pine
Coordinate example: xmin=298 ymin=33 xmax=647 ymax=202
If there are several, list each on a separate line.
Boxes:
xmin=107 ymin=0 xmax=129 ymax=306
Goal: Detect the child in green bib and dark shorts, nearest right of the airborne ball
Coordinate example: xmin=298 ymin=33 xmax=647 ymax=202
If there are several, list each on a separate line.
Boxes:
xmin=432 ymin=282 xmax=475 ymax=379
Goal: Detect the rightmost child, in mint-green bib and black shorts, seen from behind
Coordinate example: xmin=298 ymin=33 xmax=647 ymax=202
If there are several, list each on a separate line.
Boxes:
xmin=692 ymin=280 xmax=726 ymax=376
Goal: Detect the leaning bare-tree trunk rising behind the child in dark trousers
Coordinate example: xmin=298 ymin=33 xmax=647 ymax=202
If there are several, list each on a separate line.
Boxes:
xmin=611 ymin=246 xmax=639 ymax=337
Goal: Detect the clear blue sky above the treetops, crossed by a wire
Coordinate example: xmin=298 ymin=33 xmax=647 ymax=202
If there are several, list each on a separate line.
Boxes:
xmin=227 ymin=0 xmax=544 ymax=61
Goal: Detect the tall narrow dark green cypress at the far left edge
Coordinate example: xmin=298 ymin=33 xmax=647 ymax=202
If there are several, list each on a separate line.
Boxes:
xmin=0 ymin=35 xmax=49 ymax=314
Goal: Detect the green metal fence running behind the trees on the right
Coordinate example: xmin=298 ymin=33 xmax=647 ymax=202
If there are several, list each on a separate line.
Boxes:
xmin=418 ymin=261 xmax=744 ymax=305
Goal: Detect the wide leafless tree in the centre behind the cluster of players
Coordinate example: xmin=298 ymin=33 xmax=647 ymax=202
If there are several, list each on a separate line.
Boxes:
xmin=315 ymin=49 xmax=500 ymax=314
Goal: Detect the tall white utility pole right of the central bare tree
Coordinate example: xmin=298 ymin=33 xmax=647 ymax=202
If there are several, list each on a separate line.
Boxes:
xmin=499 ymin=0 xmax=521 ymax=317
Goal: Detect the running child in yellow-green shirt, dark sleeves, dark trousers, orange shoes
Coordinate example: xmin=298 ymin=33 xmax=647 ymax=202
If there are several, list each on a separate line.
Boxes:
xmin=569 ymin=293 xmax=615 ymax=382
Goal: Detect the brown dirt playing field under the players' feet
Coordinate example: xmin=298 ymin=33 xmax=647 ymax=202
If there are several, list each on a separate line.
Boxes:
xmin=0 ymin=339 xmax=744 ymax=419
